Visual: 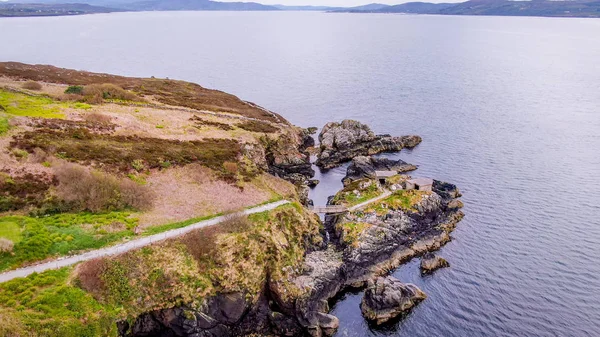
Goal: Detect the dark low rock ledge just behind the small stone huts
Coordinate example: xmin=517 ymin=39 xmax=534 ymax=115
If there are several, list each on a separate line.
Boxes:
xmin=342 ymin=156 xmax=417 ymax=186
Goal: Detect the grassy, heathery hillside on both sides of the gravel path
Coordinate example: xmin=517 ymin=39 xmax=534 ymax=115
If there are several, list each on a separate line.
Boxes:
xmin=0 ymin=63 xmax=320 ymax=337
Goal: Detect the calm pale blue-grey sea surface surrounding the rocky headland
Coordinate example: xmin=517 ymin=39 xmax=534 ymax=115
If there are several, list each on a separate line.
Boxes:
xmin=0 ymin=12 xmax=600 ymax=337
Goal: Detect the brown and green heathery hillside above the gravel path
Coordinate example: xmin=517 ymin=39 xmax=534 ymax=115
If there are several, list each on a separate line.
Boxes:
xmin=0 ymin=63 xmax=296 ymax=271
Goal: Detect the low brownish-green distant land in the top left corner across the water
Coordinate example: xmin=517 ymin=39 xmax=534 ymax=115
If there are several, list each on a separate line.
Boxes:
xmin=0 ymin=2 xmax=121 ymax=17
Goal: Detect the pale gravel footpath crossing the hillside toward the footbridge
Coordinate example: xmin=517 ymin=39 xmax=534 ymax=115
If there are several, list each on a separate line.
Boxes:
xmin=0 ymin=200 xmax=289 ymax=283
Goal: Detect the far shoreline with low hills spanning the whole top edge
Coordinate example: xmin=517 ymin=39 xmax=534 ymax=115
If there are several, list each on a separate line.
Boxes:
xmin=0 ymin=0 xmax=600 ymax=18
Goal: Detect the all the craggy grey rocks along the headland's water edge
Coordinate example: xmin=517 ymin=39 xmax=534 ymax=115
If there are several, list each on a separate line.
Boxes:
xmin=119 ymin=121 xmax=463 ymax=337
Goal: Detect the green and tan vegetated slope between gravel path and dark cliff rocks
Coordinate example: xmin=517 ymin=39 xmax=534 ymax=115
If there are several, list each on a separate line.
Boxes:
xmin=0 ymin=204 xmax=320 ymax=337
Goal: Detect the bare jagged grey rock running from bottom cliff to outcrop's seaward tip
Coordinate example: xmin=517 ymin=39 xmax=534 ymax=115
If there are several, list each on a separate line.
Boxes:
xmin=125 ymin=177 xmax=463 ymax=337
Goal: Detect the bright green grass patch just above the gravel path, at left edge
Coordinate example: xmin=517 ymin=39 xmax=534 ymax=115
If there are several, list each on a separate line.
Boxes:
xmin=0 ymin=212 xmax=138 ymax=271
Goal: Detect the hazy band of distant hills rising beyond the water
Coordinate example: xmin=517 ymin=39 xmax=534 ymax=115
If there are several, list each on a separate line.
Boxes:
xmin=0 ymin=0 xmax=600 ymax=18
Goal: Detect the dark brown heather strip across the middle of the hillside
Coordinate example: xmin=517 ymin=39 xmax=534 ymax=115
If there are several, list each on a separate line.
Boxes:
xmin=11 ymin=127 xmax=241 ymax=173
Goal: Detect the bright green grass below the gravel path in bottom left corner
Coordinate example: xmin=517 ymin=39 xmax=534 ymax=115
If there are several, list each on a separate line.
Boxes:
xmin=0 ymin=268 xmax=118 ymax=337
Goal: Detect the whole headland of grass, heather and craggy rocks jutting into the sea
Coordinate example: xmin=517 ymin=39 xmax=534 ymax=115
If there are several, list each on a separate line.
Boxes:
xmin=0 ymin=63 xmax=463 ymax=337
